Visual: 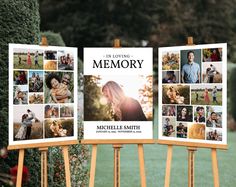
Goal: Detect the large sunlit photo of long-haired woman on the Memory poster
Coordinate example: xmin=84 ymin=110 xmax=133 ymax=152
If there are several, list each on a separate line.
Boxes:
xmin=84 ymin=75 xmax=153 ymax=122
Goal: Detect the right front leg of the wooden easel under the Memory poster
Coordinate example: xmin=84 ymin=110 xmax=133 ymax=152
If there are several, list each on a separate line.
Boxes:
xmin=138 ymin=144 xmax=146 ymax=187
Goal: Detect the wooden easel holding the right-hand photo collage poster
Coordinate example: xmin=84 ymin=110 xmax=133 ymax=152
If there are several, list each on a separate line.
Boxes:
xmin=157 ymin=37 xmax=227 ymax=187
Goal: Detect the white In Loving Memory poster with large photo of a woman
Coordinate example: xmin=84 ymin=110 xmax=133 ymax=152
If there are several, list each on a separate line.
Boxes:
xmin=84 ymin=48 xmax=153 ymax=139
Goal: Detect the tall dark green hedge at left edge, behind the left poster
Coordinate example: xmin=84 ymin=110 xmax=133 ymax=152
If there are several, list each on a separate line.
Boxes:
xmin=0 ymin=0 xmax=40 ymax=186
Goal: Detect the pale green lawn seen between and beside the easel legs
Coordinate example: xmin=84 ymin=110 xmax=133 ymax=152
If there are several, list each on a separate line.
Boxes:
xmin=91 ymin=129 xmax=236 ymax=187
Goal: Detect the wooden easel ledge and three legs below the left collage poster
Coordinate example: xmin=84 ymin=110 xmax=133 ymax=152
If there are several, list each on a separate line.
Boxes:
xmin=7 ymin=140 xmax=78 ymax=187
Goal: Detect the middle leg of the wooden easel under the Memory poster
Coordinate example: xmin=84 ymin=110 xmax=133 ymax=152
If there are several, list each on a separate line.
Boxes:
xmin=113 ymin=145 xmax=122 ymax=187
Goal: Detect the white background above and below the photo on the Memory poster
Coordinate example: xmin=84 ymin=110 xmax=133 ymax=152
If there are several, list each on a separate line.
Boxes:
xmin=84 ymin=47 xmax=153 ymax=139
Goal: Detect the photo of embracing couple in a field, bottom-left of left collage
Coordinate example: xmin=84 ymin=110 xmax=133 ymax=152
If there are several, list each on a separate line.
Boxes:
xmin=14 ymin=106 xmax=42 ymax=140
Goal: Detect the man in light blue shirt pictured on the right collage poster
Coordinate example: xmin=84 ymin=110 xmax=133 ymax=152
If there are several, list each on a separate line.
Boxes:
xmin=181 ymin=51 xmax=200 ymax=83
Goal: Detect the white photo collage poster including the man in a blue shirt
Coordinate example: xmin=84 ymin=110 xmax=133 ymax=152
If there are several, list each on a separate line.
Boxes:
xmin=158 ymin=43 xmax=227 ymax=144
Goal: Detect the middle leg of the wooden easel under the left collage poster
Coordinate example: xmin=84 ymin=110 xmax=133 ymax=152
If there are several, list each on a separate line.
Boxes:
xmin=39 ymin=147 xmax=48 ymax=187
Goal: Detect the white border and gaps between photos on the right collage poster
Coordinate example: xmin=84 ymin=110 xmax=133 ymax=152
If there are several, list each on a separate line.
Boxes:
xmin=158 ymin=43 xmax=227 ymax=145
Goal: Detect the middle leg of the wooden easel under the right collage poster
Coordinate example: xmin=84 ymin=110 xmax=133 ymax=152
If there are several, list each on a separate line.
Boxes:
xmin=188 ymin=147 xmax=197 ymax=187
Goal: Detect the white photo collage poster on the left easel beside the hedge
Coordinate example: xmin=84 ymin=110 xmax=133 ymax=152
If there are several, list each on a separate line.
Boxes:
xmin=9 ymin=44 xmax=77 ymax=145
